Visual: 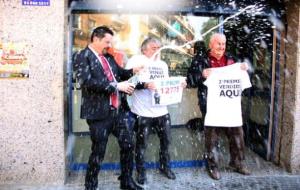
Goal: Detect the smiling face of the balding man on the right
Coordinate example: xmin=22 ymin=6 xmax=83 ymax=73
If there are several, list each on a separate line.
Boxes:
xmin=209 ymin=34 xmax=226 ymax=59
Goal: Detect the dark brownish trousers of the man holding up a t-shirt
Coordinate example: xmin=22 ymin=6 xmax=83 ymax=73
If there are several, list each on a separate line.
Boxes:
xmin=204 ymin=126 xmax=245 ymax=167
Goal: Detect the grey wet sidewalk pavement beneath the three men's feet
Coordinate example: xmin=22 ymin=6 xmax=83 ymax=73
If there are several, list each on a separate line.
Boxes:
xmin=0 ymin=151 xmax=300 ymax=190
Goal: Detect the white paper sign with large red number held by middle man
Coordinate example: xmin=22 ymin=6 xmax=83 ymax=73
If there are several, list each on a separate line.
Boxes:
xmin=152 ymin=77 xmax=185 ymax=106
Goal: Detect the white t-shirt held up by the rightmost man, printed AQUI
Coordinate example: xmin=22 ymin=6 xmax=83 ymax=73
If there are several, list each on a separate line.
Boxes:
xmin=204 ymin=63 xmax=251 ymax=127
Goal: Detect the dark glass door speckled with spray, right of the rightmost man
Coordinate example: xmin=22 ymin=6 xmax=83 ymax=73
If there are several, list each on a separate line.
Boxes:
xmin=224 ymin=16 xmax=277 ymax=160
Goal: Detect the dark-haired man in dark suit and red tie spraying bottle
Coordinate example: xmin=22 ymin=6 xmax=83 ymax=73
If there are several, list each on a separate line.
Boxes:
xmin=74 ymin=26 xmax=143 ymax=190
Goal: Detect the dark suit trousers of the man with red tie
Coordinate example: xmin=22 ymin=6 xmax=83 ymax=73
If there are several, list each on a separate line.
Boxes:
xmin=85 ymin=111 xmax=134 ymax=190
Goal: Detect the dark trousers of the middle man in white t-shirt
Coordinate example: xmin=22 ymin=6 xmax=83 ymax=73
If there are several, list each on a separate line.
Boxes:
xmin=135 ymin=114 xmax=171 ymax=172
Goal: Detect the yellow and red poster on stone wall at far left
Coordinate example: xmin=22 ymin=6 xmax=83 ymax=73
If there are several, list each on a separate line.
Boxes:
xmin=0 ymin=41 xmax=29 ymax=78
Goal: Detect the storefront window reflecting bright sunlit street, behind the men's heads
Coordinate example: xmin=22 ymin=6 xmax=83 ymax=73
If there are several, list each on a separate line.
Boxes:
xmin=72 ymin=14 xmax=217 ymax=132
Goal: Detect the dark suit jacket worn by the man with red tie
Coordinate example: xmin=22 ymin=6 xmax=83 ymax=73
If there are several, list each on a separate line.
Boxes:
xmin=73 ymin=47 xmax=133 ymax=120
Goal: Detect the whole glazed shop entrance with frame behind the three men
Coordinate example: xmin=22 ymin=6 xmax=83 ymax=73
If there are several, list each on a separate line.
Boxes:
xmin=68 ymin=0 xmax=279 ymax=169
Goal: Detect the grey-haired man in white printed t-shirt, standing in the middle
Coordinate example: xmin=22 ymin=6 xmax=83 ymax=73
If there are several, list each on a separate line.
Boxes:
xmin=126 ymin=38 xmax=176 ymax=184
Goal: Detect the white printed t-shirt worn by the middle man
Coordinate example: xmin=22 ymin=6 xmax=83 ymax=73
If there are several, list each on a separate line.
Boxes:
xmin=126 ymin=55 xmax=169 ymax=117
